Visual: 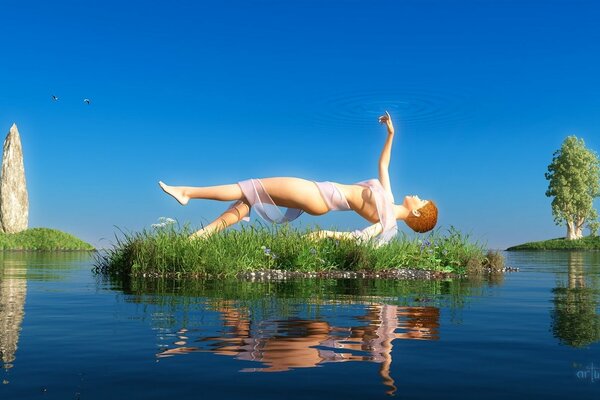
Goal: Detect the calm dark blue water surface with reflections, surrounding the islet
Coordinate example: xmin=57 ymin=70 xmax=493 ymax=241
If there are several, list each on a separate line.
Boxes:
xmin=0 ymin=252 xmax=600 ymax=399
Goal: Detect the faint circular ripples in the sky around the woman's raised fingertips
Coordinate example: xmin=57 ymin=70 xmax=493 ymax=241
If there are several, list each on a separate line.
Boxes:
xmin=313 ymin=90 xmax=469 ymax=127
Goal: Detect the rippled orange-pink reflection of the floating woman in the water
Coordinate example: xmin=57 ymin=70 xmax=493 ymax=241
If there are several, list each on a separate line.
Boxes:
xmin=158 ymin=301 xmax=439 ymax=394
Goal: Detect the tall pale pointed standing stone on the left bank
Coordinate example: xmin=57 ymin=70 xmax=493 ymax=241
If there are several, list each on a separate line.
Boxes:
xmin=0 ymin=124 xmax=29 ymax=233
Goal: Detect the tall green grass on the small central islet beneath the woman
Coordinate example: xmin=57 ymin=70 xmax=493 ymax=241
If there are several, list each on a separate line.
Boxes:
xmin=96 ymin=225 xmax=494 ymax=276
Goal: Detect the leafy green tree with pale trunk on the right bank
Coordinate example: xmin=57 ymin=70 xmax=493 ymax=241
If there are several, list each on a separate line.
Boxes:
xmin=545 ymin=136 xmax=600 ymax=239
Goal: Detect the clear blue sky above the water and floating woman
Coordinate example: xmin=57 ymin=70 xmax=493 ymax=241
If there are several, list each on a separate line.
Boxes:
xmin=0 ymin=0 xmax=600 ymax=248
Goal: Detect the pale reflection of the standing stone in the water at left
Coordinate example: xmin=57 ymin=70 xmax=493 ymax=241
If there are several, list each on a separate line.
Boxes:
xmin=0 ymin=256 xmax=27 ymax=370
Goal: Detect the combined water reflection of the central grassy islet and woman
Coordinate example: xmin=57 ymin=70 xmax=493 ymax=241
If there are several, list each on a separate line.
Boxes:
xmin=110 ymin=276 xmax=502 ymax=394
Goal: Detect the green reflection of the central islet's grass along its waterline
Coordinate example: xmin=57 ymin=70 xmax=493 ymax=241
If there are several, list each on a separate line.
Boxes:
xmin=109 ymin=276 xmax=502 ymax=325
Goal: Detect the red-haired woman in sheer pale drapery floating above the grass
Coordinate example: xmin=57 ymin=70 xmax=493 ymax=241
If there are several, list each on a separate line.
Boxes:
xmin=159 ymin=112 xmax=437 ymax=242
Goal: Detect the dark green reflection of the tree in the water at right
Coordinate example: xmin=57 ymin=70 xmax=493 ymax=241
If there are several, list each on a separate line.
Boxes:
xmin=551 ymin=252 xmax=600 ymax=347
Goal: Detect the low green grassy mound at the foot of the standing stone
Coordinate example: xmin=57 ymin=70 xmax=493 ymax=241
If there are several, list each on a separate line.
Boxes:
xmin=0 ymin=228 xmax=94 ymax=251
